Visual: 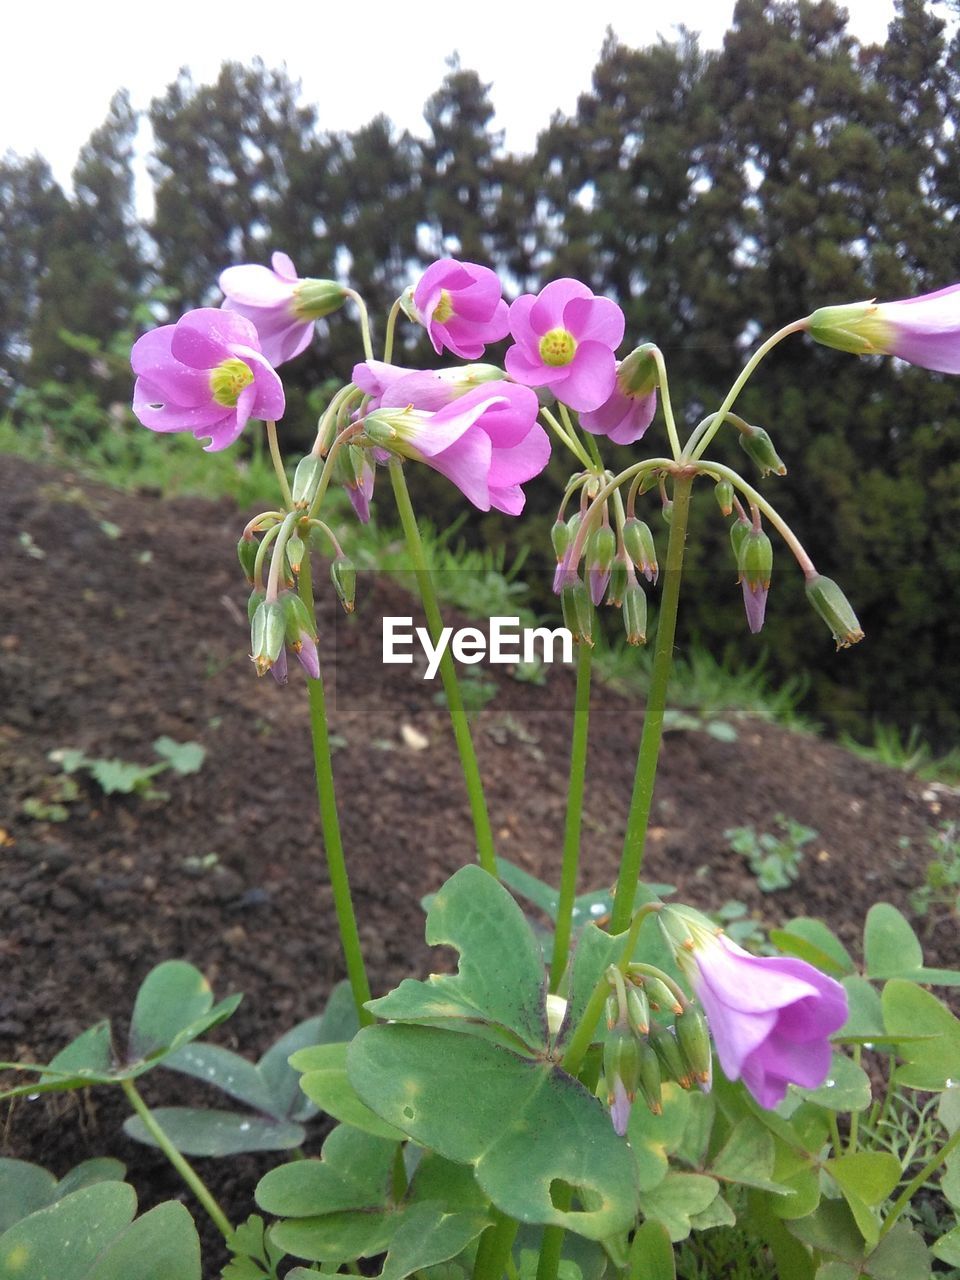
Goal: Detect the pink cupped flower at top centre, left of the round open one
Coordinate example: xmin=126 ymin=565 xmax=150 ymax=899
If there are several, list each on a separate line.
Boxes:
xmin=413 ymin=257 xmax=509 ymax=360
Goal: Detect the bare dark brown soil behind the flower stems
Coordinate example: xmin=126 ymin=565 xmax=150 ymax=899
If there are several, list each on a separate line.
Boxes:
xmin=0 ymin=458 xmax=960 ymax=1275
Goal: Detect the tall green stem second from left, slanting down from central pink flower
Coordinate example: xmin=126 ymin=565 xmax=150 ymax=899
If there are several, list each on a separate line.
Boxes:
xmin=390 ymin=457 xmax=497 ymax=877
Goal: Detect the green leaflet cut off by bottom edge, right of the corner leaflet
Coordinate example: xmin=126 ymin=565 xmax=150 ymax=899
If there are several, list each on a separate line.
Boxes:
xmin=84 ymin=1201 xmax=200 ymax=1280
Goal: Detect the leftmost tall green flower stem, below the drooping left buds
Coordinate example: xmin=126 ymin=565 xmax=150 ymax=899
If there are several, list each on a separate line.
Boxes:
xmin=297 ymin=553 xmax=375 ymax=1027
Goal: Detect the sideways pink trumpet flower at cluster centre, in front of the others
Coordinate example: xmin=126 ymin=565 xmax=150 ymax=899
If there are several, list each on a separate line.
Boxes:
xmin=365 ymin=379 xmax=550 ymax=516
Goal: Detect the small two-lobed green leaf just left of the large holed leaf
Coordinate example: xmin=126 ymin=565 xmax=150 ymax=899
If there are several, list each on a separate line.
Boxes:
xmin=256 ymin=1125 xmax=397 ymax=1217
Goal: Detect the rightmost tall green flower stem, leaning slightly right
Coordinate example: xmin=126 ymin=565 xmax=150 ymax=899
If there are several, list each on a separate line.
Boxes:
xmin=609 ymin=471 xmax=695 ymax=933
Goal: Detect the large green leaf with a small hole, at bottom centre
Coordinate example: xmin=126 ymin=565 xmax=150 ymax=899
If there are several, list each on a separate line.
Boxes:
xmin=347 ymin=1025 xmax=637 ymax=1239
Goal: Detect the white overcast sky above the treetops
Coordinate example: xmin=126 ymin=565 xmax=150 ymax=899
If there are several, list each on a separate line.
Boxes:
xmin=0 ymin=0 xmax=893 ymax=183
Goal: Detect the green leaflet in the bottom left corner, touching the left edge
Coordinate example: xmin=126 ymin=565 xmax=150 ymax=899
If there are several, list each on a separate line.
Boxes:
xmin=0 ymin=1183 xmax=137 ymax=1280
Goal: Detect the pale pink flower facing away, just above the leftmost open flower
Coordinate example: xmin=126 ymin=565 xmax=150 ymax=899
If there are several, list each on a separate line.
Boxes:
xmin=220 ymin=253 xmax=347 ymax=365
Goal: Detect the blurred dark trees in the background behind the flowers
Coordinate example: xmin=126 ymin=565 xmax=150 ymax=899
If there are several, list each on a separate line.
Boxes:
xmin=0 ymin=0 xmax=960 ymax=750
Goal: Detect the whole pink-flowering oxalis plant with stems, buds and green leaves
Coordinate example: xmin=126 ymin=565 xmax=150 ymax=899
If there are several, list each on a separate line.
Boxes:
xmin=0 ymin=253 xmax=960 ymax=1280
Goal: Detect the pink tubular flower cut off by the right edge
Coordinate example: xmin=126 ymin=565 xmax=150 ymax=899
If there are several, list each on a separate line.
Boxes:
xmin=805 ymin=284 xmax=960 ymax=374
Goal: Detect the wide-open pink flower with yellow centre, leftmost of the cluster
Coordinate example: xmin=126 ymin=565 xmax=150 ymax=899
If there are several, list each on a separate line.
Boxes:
xmin=131 ymin=307 xmax=284 ymax=452
